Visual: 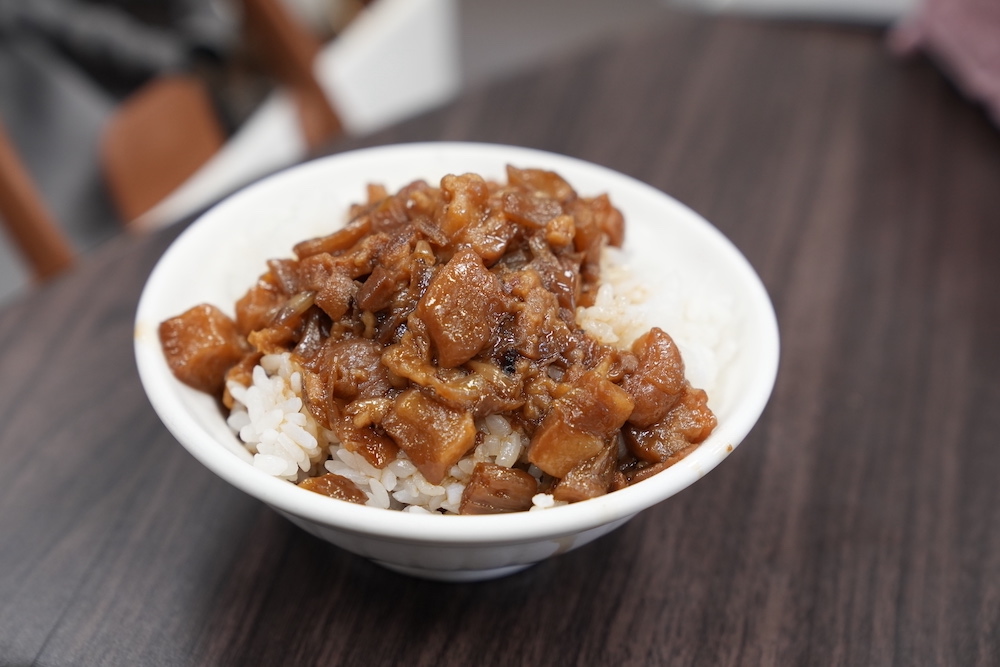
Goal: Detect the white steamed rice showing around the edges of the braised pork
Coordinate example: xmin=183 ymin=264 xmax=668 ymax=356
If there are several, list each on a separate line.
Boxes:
xmin=227 ymin=248 xmax=731 ymax=514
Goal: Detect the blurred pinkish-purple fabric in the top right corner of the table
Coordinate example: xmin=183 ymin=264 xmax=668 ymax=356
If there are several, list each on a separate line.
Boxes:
xmin=890 ymin=0 xmax=1000 ymax=126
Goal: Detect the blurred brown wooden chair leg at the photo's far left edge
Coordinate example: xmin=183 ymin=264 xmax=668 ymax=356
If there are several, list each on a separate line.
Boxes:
xmin=0 ymin=118 xmax=75 ymax=281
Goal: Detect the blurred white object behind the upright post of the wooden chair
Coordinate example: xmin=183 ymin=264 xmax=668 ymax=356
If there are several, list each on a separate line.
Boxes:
xmin=131 ymin=0 xmax=461 ymax=230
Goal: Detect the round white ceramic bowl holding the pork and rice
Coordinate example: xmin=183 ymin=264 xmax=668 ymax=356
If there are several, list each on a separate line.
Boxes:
xmin=135 ymin=143 xmax=778 ymax=581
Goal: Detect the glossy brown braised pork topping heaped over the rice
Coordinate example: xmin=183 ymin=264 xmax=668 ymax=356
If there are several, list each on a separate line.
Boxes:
xmin=160 ymin=167 xmax=716 ymax=513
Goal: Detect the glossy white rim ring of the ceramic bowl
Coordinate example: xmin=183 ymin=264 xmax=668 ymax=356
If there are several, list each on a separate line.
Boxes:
xmin=134 ymin=141 xmax=780 ymax=546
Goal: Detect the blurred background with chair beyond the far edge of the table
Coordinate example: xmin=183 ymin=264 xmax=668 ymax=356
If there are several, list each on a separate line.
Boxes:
xmin=0 ymin=0 xmax=968 ymax=306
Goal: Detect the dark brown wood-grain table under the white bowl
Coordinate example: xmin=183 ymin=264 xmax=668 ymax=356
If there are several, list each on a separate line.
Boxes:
xmin=0 ymin=14 xmax=1000 ymax=666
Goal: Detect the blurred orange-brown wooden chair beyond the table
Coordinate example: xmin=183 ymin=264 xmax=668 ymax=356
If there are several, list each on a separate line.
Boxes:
xmin=0 ymin=0 xmax=341 ymax=281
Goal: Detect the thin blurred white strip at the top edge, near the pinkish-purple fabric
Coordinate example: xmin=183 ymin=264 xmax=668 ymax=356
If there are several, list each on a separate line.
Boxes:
xmin=667 ymin=0 xmax=918 ymax=23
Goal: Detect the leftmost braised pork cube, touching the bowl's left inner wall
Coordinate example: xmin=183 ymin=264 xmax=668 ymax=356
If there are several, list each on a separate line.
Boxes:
xmin=159 ymin=304 xmax=249 ymax=396
